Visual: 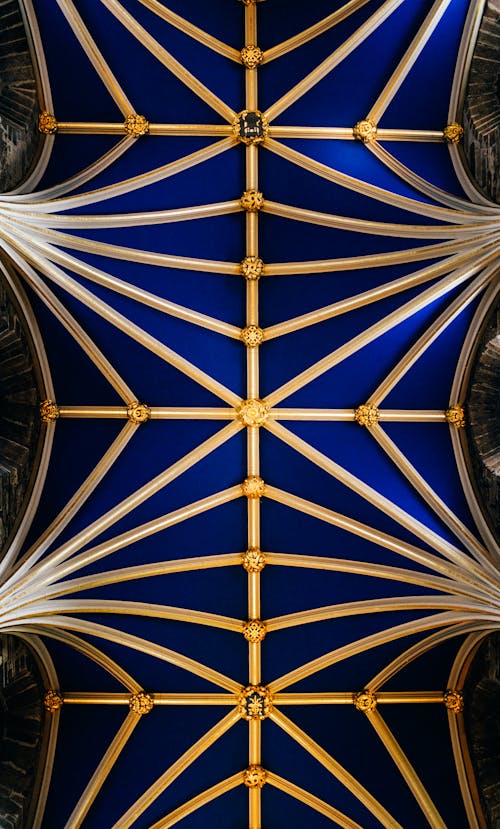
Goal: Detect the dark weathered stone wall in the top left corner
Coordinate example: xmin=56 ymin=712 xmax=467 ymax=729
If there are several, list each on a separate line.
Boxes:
xmin=0 ymin=0 xmax=42 ymax=192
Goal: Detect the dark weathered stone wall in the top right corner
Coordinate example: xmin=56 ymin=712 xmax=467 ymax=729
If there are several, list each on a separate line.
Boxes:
xmin=463 ymin=0 xmax=500 ymax=202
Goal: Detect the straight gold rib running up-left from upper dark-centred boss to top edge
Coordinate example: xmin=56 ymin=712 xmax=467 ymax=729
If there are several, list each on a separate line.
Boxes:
xmin=101 ymin=0 xmax=236 ymax=123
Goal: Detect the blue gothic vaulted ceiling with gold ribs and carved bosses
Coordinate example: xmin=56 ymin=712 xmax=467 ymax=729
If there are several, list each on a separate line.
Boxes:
xmin=0 ymin=0 xmax=500 ymax=829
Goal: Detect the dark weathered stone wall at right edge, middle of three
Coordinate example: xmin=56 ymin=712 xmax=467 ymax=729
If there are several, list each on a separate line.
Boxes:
xmin=466 ymin=301 xmax=500 ymax=539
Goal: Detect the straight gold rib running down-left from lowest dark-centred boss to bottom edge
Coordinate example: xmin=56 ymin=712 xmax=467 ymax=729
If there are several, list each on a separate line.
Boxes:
xmin=112 ymin=711 xmax=239 ymax=829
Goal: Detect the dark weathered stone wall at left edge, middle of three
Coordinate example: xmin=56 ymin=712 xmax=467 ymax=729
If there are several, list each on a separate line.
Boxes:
xmin=0 ymin=280 xmax=40 ymax=552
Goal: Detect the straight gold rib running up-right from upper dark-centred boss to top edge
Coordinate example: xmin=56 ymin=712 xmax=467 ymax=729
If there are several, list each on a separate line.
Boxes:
xmin=266 ymin=0 xmax=403 ymax=121
